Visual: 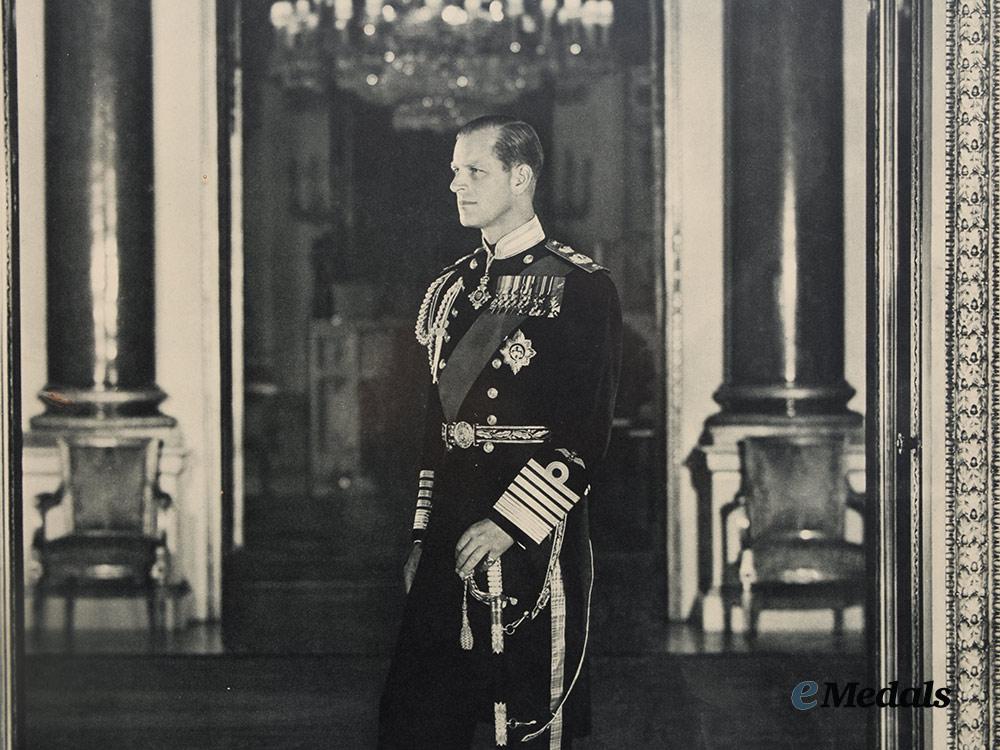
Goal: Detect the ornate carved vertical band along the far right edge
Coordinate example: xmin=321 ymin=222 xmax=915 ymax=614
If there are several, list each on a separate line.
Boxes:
xmin=945 ymin=0 xmax=1000 ymax=748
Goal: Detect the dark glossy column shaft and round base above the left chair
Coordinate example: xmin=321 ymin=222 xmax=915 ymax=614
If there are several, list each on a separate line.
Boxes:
xmin=32 ymin=0 xmax=173 ymax=430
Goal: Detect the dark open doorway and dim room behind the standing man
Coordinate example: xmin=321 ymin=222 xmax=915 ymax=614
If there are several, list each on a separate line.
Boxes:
xmin=224 ymin=0 xmax=666 ymax=652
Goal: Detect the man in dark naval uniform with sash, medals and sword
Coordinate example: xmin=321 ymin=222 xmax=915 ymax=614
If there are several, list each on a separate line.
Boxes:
xmin=379 ymin=116 xmax=621 ymax=750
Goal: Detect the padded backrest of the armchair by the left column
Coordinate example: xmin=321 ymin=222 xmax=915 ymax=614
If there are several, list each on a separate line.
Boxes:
xmin=59 ymin=436 xmax=160 ymax=536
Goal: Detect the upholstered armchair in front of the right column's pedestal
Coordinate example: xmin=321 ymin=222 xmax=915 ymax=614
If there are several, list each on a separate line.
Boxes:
xmin=722 ymin=435 xmax=865 ymax=636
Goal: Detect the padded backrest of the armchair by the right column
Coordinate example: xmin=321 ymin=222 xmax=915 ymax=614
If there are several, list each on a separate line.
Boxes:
xmin=740 ymin=436 xmax=848 ymax=543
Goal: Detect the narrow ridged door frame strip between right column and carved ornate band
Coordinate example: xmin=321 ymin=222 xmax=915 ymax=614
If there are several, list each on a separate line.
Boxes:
xmin=865 ymin=0 xmax=930 ymax=750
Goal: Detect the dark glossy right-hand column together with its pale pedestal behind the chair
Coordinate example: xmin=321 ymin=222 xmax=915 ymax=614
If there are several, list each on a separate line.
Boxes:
xmin=690 ymin=0 xmax=864 ymax=630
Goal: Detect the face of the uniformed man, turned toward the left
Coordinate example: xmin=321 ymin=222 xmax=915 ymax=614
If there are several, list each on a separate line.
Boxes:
xmin=451 ymin=128 xmax=515 ymax=231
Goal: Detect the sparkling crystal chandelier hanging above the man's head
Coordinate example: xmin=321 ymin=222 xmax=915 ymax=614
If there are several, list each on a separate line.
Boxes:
xmin=271 ymin=0 xmax=614 ymax=130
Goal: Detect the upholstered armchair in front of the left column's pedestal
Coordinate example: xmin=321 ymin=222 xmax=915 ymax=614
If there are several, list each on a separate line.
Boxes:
xmin=33 ymin=436 xmax=171 ymax=645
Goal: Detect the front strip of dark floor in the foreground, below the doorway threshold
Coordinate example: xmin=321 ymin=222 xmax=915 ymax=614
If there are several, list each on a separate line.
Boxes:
xmin=22 ymin=653 xmax=867 ymax=750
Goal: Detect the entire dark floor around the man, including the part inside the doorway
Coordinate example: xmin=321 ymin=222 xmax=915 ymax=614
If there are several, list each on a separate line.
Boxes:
xmin=20 ymin=484 xmax=870 ymax=750
